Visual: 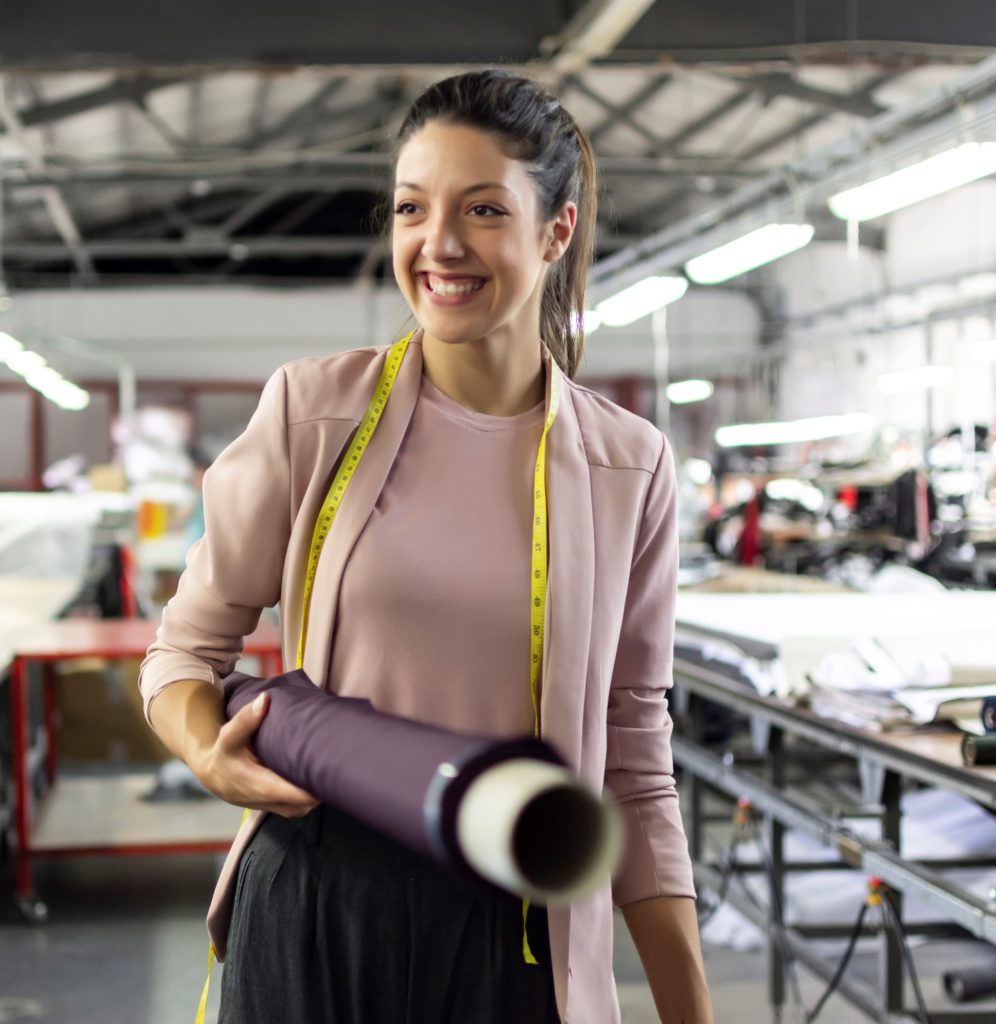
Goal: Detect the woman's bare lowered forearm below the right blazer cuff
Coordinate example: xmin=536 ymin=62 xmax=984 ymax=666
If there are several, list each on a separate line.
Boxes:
xmin=622 ymin=896 xmax=712 ymax=1024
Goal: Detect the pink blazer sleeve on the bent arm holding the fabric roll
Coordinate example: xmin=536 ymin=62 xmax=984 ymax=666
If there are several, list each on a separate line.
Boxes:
xmin=138 ymin=369 xmax=292 ymax=724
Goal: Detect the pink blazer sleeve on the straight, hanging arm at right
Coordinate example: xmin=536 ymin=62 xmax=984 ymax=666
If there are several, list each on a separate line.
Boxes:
xmin=605 ymin=435 xmax=695 ymax=906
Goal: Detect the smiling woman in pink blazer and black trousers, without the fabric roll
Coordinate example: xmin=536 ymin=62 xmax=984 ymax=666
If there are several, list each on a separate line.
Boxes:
xmin=141 ymin=72 xmax=711 ymax=1024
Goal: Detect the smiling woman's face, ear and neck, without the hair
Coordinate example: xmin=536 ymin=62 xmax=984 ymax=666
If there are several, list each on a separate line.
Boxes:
xmin=392 ymin=121 xmax=577 ymax=416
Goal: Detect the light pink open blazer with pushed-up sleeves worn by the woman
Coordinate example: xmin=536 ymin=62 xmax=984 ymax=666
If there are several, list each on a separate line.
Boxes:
xmin=139 ymin=336 xmax=694 ymax=1024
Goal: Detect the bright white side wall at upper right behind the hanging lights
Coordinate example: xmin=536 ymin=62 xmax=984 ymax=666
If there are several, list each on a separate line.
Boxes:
xmin=772 ymin=179 xmax=996 ymax=434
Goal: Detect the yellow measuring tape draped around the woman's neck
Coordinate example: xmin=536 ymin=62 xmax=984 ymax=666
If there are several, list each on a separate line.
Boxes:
xmin=194 ymin=331 xmax=560 ymax=1024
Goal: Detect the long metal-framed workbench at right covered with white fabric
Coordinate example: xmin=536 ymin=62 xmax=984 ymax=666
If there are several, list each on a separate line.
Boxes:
xmin=673 ymin=591 xmax=996 ymax=1024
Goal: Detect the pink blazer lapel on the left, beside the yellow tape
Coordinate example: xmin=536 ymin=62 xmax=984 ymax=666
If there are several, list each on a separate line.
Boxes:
xmin=304 ymin=344 xmax=422 ymax=686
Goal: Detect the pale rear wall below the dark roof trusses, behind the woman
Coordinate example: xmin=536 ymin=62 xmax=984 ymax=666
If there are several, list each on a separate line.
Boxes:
xmin=0 ymin=280 xmax=760 ymax=381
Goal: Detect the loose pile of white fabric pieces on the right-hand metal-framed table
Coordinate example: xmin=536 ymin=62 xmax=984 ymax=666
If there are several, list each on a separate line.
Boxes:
xmin=809 ymin=637 xmax=996 ymax=731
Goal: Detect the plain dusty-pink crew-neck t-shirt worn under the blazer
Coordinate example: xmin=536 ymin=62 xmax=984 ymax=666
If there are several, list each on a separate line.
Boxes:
xmin=329 ymin=375 xmax=545 ymax=736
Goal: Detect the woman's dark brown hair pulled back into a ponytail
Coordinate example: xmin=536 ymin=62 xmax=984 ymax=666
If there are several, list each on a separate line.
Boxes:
xmin=394 ymin=70 xmax=598 ymax=379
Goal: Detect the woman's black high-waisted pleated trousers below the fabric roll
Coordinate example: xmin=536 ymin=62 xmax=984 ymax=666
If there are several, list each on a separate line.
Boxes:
xmin=218 ymin=806 xmax=560 ymax=1024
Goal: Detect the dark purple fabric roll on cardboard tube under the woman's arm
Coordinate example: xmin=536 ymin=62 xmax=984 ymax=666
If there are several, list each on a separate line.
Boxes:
xmin=223 ymin=670 xmax=622 ymax=903
